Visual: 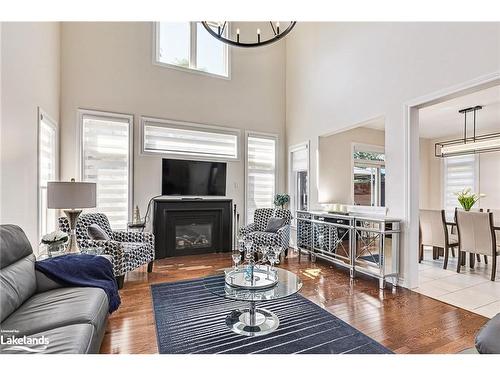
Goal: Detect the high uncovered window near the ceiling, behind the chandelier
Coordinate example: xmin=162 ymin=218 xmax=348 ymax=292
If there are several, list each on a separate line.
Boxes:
xmin=155 ymin=22 xmax=229 ymax=77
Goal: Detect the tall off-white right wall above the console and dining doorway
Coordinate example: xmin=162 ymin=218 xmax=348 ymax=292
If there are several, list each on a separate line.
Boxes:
xmin=286 ymin=23 xmax=500 ymax=284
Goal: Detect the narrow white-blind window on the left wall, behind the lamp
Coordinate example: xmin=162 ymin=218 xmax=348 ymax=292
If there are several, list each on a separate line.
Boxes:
xmin=38 ymin=110 xmax=59 ymax=237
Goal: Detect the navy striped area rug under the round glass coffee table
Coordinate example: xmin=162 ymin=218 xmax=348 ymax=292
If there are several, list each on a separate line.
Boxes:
xmin=151 ymin=276 xmax=391 ymax=354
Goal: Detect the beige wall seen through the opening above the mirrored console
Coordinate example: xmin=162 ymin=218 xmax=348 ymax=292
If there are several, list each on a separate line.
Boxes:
xmin=318 ymin=127 xmax=385 ymax=205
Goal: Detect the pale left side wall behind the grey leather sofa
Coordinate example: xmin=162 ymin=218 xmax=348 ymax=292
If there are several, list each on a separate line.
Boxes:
xmin=0 ymin=22 xmax=60 ymax=250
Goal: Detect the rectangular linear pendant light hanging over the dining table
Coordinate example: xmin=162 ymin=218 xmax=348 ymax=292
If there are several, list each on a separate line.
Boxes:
xmin=434 ymin=105 xmax=500 ymax=158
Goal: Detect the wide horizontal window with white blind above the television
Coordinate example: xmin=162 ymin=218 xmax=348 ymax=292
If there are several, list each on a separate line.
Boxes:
xmin=142 ymin=117 xmax=240 ymax=160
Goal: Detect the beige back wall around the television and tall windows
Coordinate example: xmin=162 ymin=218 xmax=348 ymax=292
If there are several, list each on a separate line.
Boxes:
xmin=61 ymin=22 xmax=285 ymax=229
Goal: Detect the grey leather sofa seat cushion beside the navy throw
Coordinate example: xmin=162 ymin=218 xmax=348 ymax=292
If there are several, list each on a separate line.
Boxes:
xmin=2 ymin=288 xmax=108 ymax=335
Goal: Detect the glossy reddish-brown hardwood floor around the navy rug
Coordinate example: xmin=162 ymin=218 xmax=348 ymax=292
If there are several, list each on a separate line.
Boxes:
xmin=101 ymin=251 xmax=487 ymax=354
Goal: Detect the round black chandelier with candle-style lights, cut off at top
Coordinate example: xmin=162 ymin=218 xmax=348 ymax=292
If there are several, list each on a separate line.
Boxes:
xmin=201 ymin=21 xmax=297 ymax=48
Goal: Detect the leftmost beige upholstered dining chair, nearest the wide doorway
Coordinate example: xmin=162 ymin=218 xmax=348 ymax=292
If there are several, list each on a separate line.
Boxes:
xmin=419 ymin=210 xmax=458 ymax=269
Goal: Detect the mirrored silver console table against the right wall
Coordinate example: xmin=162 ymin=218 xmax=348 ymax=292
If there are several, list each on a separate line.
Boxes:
xmin=296 ymin=211 xmax=401 ymax=289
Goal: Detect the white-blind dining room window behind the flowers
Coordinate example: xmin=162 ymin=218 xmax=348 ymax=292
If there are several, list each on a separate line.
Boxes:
xmin=443 ymin=155 xmax=479 ymax=216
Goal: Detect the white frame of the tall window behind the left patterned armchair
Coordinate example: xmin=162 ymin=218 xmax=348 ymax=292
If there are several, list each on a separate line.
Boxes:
xmin=76 ymin=108 xmax=134 ymax=230
